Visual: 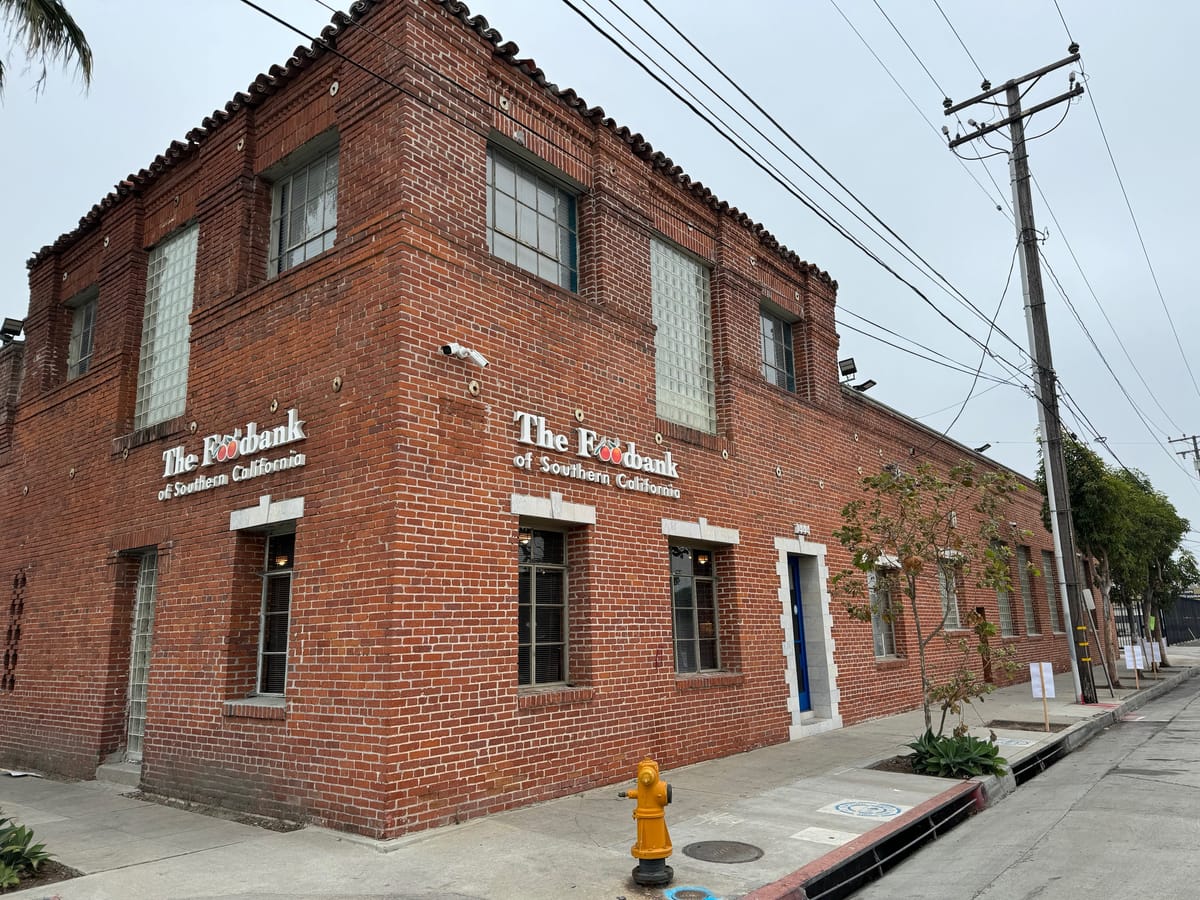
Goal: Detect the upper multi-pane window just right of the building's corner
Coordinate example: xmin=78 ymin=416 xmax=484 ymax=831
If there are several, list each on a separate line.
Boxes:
xmin=487 ymin=149 xmax=578 ymax=290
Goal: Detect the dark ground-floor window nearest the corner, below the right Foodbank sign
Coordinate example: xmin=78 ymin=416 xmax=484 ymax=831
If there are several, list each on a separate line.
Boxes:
xmin=517 ymin=528 xmax=566 ymax=686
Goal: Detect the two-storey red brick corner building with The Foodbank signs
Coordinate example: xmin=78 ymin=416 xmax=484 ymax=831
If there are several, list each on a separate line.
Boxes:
xmin=0 ymin=0 xmax=1068 ymax=836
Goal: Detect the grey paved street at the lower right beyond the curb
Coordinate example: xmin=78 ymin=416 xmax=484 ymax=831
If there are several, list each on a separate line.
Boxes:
xmin=854 ymin=679 xmax=1200 ymax=900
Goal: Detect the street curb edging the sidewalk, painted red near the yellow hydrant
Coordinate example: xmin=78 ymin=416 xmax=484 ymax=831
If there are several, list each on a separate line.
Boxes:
xmin=742 ymin=667 xmax=1200 ymax=900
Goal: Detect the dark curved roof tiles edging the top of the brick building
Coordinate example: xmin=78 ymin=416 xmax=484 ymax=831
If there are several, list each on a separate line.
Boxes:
xmin=25 ymin=0 xmax=838 ymax=290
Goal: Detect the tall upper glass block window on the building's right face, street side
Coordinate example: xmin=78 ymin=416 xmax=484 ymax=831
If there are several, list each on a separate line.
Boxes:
xmin=650 ymin=240 xmax=716 ymax=433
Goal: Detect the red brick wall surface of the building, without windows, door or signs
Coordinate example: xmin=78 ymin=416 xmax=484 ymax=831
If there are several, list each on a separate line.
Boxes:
xmin=0 ymin=0 xmax=1067 ymax=836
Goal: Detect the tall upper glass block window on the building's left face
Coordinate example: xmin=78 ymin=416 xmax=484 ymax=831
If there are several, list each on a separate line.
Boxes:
xmin=133 ymin=224 xmax=199 ymax=428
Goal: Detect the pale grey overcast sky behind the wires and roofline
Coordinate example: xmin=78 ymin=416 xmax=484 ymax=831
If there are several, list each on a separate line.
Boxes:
xmin=0 ymin=0 xmax=1200 ymax=546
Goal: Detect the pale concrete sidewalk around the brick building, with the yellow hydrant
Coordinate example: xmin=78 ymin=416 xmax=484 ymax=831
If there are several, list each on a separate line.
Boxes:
xmin=0 ymin=647 xmax=1200 ymax=900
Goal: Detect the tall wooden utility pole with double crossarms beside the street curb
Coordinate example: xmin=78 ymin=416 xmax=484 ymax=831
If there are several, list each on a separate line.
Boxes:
xmin=942 ymin=49 xmax=1096 ymax=703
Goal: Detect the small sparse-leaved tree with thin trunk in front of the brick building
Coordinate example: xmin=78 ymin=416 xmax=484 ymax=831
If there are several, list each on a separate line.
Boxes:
xmin=833 ymin=463 xmax=1022 ymax=731
